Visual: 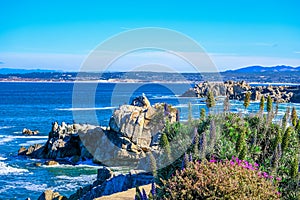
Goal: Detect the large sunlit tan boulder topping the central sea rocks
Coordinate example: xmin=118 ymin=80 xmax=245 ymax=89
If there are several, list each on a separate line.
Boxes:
xmin=109 ymin=96 xmax=178 ymax=147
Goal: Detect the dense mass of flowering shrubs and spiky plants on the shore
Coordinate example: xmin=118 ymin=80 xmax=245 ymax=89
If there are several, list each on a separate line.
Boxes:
xmin=136 ymin=93 xmax=300 ymax=199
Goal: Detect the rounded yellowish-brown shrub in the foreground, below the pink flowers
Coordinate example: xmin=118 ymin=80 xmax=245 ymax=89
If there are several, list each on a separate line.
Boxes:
xmin=158 ymin=158 xmax=280 ymax=199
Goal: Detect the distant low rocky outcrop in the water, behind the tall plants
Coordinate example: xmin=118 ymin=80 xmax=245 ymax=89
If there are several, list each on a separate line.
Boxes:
xmin=182 ymin=81 xmax=300 ymax=103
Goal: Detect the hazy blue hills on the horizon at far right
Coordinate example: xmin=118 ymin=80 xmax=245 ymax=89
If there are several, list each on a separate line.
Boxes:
xmin=225 ymin=65 xmax=300 ymax=73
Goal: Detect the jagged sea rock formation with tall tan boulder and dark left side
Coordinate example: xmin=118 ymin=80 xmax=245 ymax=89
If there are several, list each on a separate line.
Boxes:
xmin=18 ymin=96 xmax=179 ymax=167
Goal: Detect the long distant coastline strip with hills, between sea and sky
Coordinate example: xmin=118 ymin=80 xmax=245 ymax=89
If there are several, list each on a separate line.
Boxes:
xmin=0 ymin=65 xmax=300 ymax=84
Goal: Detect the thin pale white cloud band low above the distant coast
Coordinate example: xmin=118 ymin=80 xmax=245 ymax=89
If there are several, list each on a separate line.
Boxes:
xmin=0 ymin=51 xmax=300 ymax=72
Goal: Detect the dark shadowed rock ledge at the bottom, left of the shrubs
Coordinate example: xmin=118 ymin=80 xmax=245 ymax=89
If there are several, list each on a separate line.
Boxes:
xmin=69 ymin=167 xmax=153 ymax=200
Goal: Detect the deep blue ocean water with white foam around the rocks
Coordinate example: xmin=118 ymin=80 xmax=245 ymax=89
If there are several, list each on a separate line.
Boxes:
xmin=0 ymin=82 xmax=300 ymax=199
